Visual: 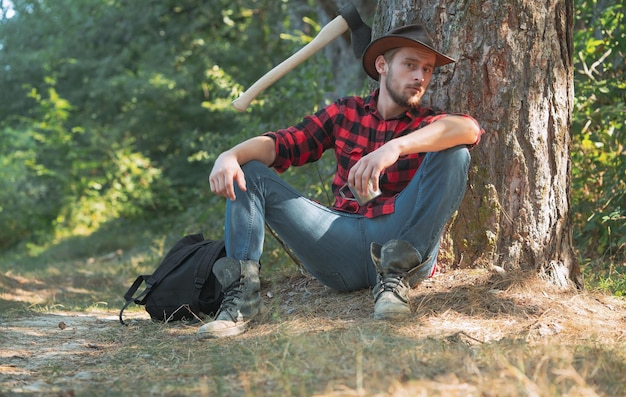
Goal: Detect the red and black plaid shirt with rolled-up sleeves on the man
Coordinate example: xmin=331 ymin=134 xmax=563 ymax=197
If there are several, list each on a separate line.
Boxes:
xmin=264 ymin=90 xmax=478 ymax=218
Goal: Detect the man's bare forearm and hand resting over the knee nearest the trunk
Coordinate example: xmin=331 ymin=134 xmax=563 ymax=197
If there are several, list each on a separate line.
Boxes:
xmin=348 ymin=116 xmax=480 ymax=194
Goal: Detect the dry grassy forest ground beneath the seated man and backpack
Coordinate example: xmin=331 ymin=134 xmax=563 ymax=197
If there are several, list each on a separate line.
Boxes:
xmin=0 ymin=258 xmax=626 ymax=397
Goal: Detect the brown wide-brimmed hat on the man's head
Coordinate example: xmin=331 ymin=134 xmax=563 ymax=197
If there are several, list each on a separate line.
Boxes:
xmin=363 ymin=25 xmax=455 ymax=80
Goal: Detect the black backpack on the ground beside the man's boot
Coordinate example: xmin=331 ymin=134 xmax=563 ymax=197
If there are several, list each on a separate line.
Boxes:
xmin=120 ymin=234 xmax=226 ymax=325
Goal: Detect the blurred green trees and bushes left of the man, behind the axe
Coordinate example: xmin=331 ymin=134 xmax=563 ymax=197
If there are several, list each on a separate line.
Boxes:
xmin=0 ymin=0 xmax=329 ymax=247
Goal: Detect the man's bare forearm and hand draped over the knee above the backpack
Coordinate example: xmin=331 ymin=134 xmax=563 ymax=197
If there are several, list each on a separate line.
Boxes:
xmin=209 ymin=136 xmax=276 ymax=200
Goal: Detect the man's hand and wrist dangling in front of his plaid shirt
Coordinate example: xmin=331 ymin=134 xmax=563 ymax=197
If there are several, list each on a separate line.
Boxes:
xmin=348 ymin=140 xmax=400 ymax=196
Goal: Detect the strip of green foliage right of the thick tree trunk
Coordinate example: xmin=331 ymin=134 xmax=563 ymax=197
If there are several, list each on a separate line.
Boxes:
xmin=572 ymin=0 xmax=626 ymax=294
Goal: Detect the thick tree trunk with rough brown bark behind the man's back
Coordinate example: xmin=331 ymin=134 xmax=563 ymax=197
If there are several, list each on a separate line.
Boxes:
xmin=372 ymin=0 xmax=582 ymax=287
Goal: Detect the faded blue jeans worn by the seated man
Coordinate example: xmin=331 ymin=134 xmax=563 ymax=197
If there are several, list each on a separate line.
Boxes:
xmin=225 ymin=145 xmax=470 ymax=291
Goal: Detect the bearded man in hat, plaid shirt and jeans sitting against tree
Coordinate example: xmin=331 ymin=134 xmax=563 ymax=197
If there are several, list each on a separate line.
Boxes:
xmin=197 ymin=25 xmax=482 ymax=339
